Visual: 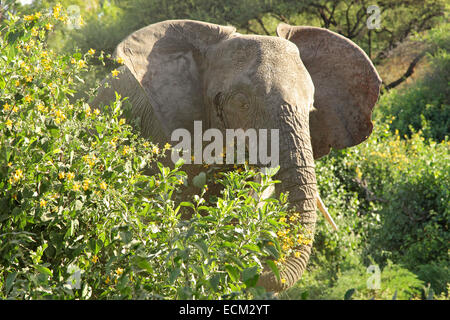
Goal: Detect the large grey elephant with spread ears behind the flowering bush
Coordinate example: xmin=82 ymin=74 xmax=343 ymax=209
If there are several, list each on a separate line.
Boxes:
xmin=91 ymin=20 xmax=381 ymax=292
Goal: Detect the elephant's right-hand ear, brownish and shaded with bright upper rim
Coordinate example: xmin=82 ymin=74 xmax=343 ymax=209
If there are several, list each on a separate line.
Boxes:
xmin=277 ymin=23 xmax=381 ymax=159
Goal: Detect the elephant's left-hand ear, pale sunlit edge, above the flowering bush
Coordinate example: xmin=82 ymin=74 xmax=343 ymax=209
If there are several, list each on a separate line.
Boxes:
xmin=114 ymin=20 xmax=235 ymax=136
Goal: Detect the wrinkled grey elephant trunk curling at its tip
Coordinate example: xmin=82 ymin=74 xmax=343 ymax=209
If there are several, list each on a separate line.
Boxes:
xmin=259 ymin=105 xmax=317 ymax=292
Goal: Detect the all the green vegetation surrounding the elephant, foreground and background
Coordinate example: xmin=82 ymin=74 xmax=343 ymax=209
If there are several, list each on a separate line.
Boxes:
xmin=0 ymin=0 xmax=450 ymax=299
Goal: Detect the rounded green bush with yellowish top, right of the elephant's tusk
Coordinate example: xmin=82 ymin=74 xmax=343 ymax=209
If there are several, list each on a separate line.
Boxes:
xmin=326 ymin=121 xmax=450 ymax=292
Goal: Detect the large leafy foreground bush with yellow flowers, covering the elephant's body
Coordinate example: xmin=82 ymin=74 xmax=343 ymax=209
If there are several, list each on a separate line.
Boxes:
xmin=0 ymin=6 xmax=300 ymax=299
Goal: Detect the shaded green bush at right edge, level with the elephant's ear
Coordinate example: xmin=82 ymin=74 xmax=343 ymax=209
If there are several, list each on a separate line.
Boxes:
xmin=376 ymin=23 xmax=450 ymax=141
